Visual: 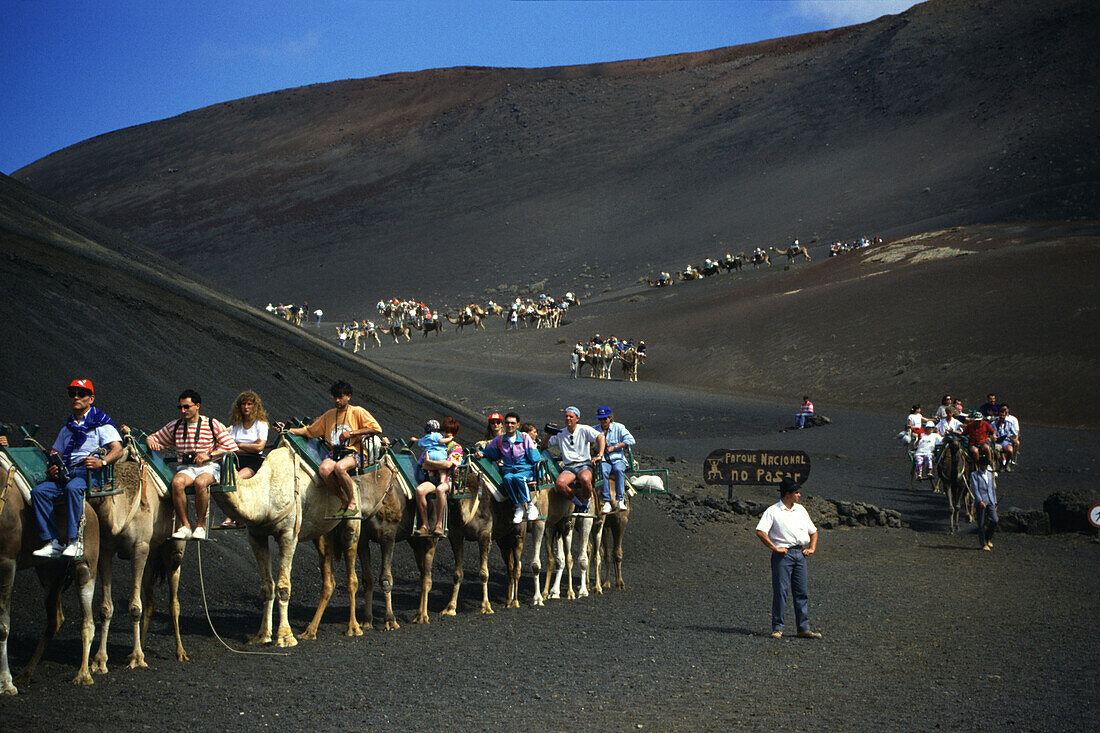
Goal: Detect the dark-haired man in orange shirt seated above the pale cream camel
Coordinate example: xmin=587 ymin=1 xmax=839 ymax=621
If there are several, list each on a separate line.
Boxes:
xmin=288 ymin=380 xmax=389 ymax=519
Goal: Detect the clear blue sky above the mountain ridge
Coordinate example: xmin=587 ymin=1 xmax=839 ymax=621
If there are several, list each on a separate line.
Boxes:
xmin=0 ymin=0 xmax=915 ymax=174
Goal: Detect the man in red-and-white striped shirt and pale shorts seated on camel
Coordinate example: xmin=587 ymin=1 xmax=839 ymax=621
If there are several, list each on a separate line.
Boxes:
xmin=145 ymin=390 xmax=237 ymax=539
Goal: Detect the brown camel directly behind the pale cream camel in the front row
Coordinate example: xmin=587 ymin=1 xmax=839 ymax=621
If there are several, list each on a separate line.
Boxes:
xmin=303 ymin=452 xmax=437 ymax=638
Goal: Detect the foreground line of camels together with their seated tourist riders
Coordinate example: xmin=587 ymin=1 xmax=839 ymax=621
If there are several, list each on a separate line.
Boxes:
xmin=0 ymin=380 xmax=668 ymax=694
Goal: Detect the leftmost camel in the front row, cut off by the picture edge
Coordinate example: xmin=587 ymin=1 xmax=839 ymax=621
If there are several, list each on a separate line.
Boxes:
xmin=0 ymin=453 xmax=99 ymax=694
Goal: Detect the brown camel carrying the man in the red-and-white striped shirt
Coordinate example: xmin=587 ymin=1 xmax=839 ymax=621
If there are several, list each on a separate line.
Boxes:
xmin=88 ymin=435 xmax=188 ymax=675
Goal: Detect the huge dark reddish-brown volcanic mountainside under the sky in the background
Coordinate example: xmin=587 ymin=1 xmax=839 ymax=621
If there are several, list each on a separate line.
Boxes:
xmin=10 ymin=0 xmax=1100 ymax=316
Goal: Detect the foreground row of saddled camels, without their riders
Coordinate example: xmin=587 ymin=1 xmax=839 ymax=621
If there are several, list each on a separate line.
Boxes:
xmin=0 ymin=416 xmax=668 ymax=694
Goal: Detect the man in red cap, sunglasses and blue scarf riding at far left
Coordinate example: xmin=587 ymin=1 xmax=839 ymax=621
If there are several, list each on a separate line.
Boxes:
xmin=31 ymin=380 xmax=122 ymax=557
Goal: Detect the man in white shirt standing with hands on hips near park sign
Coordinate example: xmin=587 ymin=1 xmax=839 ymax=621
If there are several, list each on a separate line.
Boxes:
xmin=757 ymin=478 xmax=822 ymax=638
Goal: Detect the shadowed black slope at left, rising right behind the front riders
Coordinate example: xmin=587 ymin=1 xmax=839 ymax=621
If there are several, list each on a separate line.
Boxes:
xmin=0 ymin=176 xmax=479 ymax=431
